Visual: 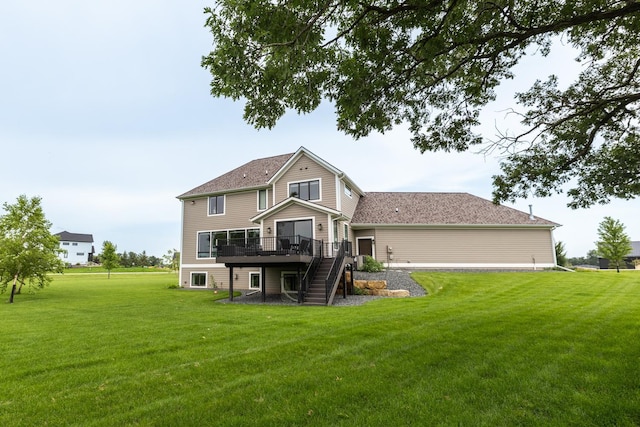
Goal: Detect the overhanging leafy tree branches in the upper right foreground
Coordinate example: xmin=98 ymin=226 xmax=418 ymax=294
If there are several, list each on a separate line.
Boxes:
xmin=202 ymin=0 xmax=640 ymax=208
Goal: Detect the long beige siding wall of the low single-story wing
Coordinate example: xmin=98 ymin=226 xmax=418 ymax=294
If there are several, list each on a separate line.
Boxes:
xmin=374 ymin=228 xmax=554 ymax=264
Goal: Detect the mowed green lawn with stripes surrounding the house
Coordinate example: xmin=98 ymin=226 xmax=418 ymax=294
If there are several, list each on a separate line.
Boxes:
xmin=0 ymin=272 xmax=640 ymax=426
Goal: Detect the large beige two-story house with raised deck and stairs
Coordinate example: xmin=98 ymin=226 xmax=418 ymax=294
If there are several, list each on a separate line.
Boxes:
xmin=177 ymin=147 xmax=558 ymax=304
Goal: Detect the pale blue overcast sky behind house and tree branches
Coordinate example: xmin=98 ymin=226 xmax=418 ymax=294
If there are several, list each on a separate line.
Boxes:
xmin=0 ymin=0 xmax=640 ymax=256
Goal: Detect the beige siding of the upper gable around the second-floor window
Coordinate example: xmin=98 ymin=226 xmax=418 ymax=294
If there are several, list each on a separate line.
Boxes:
xmin=274 ymin=155 xmax=336 ymax=209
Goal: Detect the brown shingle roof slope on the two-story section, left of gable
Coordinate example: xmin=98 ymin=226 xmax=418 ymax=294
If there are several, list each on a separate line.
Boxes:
xmin=178 ymin=153 xmax=293 ymax=199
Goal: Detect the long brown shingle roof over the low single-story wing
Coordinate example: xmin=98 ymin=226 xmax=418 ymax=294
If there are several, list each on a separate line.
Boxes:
xmin=351 ymin=192 xmax=559 ymax=227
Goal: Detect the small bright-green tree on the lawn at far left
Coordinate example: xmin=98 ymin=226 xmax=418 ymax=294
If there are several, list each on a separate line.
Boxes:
xmin=0 ymin=195 xmax=64 ymax=303
